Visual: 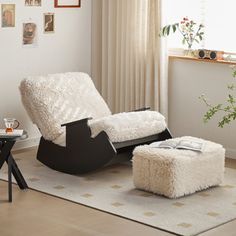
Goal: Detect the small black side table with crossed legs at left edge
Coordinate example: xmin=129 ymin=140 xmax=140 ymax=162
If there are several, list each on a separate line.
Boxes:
xmin=0 ymin=131 xmax=28 ymax=202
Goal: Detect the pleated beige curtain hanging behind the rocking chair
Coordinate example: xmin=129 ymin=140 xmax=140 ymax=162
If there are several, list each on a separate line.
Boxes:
xmin=92 ymin=0 xmax=167 ymax=116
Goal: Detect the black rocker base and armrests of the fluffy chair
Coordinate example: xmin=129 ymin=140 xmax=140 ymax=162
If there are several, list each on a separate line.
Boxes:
xmin=37 ymin=118 xmax=172 ymax=174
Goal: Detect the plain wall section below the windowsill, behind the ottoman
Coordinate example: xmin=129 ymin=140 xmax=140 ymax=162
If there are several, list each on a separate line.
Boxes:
xmin=169 ymin=58 xmax=236 ymax=158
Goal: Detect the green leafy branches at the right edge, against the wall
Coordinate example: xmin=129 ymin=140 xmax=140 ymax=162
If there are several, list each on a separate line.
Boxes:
xmin=199 ymin=66 xmax=236 ymax=128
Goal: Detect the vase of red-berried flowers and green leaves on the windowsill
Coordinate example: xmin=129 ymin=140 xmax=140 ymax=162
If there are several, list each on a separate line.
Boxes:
xmin=160 ymin=17 xmax=204 ymax=56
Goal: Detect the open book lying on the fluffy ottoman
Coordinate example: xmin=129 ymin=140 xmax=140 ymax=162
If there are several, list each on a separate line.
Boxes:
xmin=150 ymin=139 xmax=203 ymax=152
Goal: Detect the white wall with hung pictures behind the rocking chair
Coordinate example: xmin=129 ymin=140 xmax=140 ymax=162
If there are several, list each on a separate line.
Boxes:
xmin=0 ymin=0 xmax=91 ymax=148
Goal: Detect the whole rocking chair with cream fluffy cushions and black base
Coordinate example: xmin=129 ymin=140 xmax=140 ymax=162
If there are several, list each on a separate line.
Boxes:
xmin=20 ymin=72 xmax=171 ymax=174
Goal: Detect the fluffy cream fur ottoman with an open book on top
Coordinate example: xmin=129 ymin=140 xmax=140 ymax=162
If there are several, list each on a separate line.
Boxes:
xmin=133 ymin=136 xmax=225 ymax=198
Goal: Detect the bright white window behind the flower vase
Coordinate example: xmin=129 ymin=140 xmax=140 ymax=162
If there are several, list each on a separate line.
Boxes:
xmin=163 ymin=0 xmax=236 ymax=52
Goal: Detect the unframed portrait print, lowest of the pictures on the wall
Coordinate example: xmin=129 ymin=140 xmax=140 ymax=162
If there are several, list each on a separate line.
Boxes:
xmin=23 ymin=23 xmax=37 ymax=46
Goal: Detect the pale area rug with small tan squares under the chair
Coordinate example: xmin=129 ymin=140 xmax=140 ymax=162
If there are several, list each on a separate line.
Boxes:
xmin=0 ymin=149 xmax=236 ymax=235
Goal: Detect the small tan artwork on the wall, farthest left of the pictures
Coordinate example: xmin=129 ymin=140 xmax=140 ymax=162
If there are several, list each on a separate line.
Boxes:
xmin=2 ymin=4 xmax=15 ymax=27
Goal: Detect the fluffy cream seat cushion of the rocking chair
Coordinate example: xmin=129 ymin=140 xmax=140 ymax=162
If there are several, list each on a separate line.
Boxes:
xmin=53 ymin=111 xmax=166 ymax=146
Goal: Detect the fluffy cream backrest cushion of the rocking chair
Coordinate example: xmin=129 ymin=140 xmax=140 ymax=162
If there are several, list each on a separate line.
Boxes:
xmin=20 ymin=72 xmax=111 ymax=141
